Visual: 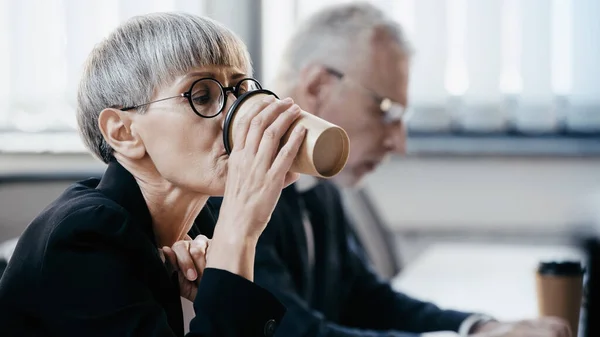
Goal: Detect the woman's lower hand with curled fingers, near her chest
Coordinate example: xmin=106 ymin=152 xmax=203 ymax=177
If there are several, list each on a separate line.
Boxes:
xmin=162 ymin=235 xmax=210 ymax=302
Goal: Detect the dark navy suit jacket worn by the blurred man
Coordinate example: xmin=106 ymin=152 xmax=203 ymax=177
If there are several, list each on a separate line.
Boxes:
xmin=213 ymin=181 xmax=470 ymax=337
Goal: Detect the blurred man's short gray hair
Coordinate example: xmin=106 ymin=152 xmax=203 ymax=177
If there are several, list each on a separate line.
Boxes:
xmin=274 ymin=2 xmax=412 ymax=96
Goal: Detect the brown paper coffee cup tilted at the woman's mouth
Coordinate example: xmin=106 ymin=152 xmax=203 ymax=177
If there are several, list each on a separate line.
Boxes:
xmin=223 ymin=89 xmax=350 ymax=178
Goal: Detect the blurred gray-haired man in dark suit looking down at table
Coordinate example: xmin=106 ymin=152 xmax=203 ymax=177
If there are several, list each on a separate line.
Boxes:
xmin=212 ymin=4 xmax=570 ymax=337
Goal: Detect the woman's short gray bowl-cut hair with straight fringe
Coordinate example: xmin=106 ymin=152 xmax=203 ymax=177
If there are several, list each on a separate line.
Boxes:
xmin=77 ymin=13 xmax=252 ymax=163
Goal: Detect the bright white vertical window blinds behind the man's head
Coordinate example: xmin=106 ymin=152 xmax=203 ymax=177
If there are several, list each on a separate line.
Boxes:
xmin=263 ymin=0 xmax=600 ymax=133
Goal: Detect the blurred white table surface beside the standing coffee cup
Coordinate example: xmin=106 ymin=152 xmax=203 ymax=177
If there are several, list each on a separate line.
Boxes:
xmin=392 ymin=243 xmax=584 ymax=321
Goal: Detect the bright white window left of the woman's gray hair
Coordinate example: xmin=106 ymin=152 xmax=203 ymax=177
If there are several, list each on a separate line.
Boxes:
xmin=0 ymin=0 xmax=205 ymax=152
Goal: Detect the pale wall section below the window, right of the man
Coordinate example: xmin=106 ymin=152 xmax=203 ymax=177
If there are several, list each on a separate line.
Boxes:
xmin=366 ymin=157 xmax=600 ymax=233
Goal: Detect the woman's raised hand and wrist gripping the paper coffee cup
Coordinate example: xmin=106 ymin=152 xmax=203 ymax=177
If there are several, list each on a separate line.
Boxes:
xmin=207 ymin=96 xmax=306 ymax=280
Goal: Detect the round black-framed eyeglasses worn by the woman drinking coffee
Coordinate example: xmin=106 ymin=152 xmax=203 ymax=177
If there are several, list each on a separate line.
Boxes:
xmin=121 ymin=77 xmax=262 ymax=118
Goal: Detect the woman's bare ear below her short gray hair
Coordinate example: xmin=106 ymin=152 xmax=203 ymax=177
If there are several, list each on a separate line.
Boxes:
xmin=98 ymin=108 xmax=146 ymax=159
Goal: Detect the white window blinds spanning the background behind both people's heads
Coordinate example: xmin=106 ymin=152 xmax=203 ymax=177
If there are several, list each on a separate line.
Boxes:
xmin=0 ymin=0 xmax=600 ymax=151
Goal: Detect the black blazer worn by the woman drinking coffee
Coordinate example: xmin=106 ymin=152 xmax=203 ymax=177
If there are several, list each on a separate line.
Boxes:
xmin=0 ymin=161 xmax=285 ymax=337
